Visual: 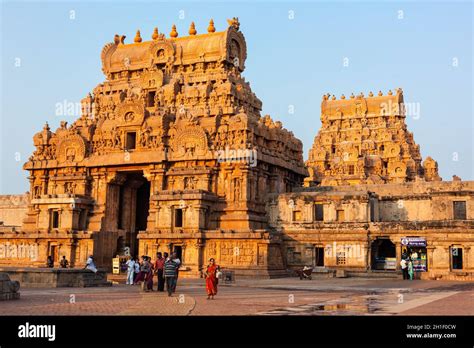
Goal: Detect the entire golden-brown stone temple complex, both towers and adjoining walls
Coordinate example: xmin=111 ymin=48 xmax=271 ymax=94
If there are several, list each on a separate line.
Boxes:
xmin=0 ymin=18 xmax=474 ymax=279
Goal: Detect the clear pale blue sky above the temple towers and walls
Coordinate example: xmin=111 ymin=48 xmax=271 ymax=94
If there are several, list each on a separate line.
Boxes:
xmin=0 ymin=1 xmax=474 ymax=194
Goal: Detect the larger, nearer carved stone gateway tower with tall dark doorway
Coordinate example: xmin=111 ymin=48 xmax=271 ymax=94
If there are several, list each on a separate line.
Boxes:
xmin=23 ymin=18 xmax=306 ymax=275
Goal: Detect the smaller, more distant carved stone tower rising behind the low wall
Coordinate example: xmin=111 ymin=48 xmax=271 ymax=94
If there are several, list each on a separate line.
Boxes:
xmin=305 ymin=89 xmax=441 ymax=186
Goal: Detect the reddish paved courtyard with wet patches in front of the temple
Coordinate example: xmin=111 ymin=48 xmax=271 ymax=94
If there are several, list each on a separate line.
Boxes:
xmin=0 ymin=278 xmax=474 ymax=315
